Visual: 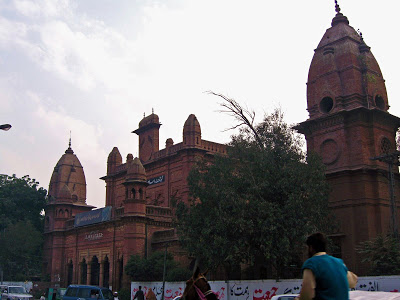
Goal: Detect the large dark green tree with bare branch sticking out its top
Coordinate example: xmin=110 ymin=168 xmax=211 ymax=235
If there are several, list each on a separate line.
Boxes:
xmin=177 ymin=95 xmax=332 ymax=277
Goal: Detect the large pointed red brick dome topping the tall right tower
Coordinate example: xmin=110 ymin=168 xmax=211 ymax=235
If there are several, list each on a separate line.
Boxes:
xmin=307 ymin=5 xmax=389 ymax=119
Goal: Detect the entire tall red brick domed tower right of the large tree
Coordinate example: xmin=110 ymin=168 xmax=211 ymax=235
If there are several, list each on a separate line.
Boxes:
xmin=296 ymin=1 xmax=400 ymax=275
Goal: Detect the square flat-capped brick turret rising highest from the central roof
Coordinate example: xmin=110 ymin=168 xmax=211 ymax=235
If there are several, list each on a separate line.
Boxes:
xmin=132 ymin=112 xmax=161 ymax=162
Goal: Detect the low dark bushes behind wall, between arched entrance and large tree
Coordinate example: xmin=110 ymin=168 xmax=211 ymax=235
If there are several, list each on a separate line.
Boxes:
xmin=125 ymin=251 xmax=191 ymax=281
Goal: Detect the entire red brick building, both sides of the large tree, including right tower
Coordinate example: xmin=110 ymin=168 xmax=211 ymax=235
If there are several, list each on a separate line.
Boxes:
xmin=44 ymin=2 xmax=400 ymax=290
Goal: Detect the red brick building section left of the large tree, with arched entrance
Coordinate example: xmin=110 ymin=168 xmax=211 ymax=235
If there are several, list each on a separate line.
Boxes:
xmin=44 ymin=113 xmax=225 ymax=290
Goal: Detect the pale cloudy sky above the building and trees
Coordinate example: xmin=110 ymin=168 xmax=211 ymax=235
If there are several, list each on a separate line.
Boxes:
xmin=0 ymin=0 xmax=400 ymax=207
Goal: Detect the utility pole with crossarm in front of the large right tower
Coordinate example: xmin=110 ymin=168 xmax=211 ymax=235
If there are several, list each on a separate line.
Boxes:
xmin=371 ymin=151 xmax=400 ymax=240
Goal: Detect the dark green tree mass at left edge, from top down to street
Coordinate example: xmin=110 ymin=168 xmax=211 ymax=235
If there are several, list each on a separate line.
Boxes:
xmin=0 ymin=175 xmax=47 ymax=280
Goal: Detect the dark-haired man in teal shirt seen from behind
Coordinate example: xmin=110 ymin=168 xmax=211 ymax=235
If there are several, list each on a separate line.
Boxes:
xmin=296 ymin=232 xmax=357 ymax=300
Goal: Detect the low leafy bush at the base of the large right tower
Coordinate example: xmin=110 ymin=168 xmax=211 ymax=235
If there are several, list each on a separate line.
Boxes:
xmin=357 ymin=234 xmax=400 ymax=275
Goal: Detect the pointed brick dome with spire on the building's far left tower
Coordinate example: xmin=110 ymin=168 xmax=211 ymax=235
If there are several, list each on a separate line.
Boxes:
xmin=49 ymin=143 xmax=86 ymax=204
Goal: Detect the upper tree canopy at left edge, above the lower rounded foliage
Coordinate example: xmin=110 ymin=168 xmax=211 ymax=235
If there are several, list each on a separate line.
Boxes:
xmin=0 ymin=174 xmax=47 ymax=232
